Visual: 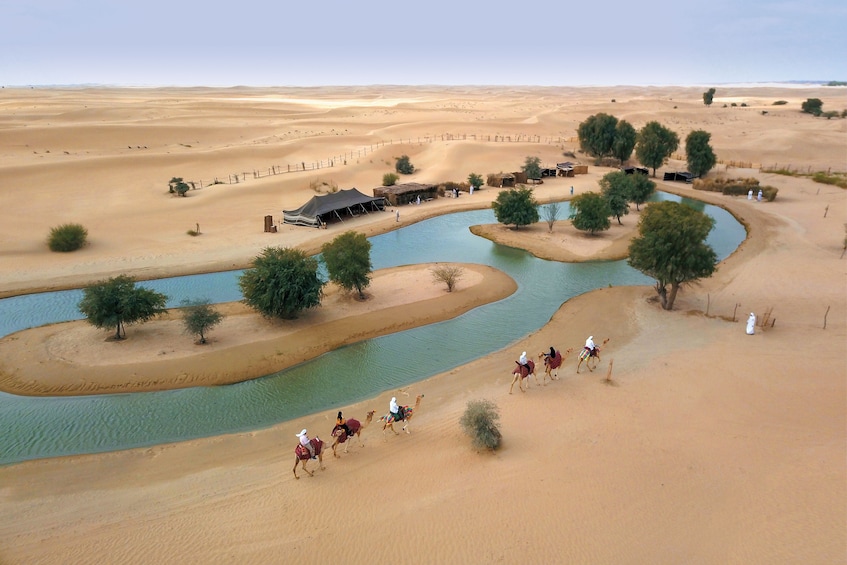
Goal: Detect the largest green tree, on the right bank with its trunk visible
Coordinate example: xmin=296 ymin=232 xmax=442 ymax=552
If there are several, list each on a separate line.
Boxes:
xmin=627 ymin=201 xmax=717 ymax=310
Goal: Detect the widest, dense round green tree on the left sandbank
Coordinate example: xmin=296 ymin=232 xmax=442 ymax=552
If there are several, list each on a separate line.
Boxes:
xmin=238 ymin=247 xmax=326 ymax=320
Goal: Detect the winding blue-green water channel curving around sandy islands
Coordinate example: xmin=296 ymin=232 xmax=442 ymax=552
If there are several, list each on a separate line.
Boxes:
xmin=0 ymin=193 xmax=746 ymax=465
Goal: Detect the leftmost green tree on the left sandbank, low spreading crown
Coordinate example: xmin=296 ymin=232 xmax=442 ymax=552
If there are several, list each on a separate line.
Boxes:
xmin=77 ymin=275 xmax=168 ymax=340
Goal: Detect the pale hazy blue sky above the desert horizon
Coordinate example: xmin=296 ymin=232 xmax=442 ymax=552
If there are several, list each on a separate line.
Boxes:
xmin=0 ymin=0 xmax=847 ymax=86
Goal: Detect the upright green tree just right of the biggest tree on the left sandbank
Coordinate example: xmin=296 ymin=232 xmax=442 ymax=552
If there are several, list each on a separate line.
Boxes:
xmin=321 ymin=231 xmax=373 ymax=299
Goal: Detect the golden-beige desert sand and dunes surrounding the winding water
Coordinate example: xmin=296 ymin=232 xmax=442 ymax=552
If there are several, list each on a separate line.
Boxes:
xmin=0 ymin=87 xmax=847 ymax=564
